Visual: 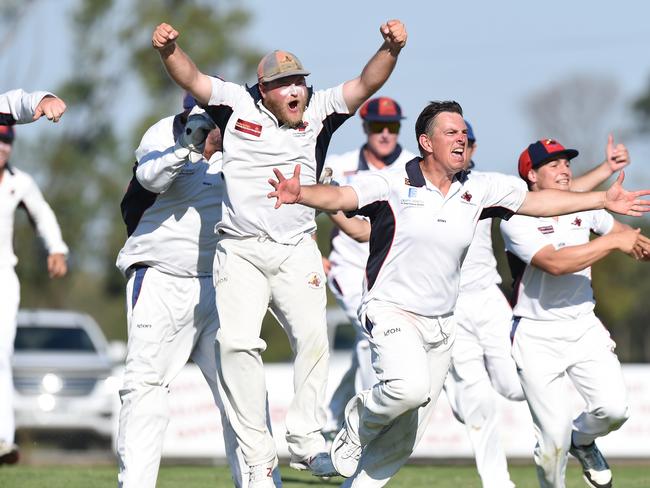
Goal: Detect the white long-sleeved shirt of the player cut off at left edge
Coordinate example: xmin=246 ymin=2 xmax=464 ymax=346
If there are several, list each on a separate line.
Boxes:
xmin=0 ymin=166 xmax=68 ymax=266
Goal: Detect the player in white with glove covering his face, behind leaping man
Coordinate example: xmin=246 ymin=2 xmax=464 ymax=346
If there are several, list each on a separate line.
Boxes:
xmin=117 ymin=95 xmax=281 ymax=488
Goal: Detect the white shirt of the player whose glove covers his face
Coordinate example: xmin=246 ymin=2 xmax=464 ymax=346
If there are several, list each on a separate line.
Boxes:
xmin=116 ymin=115 xmax=224 ymax=277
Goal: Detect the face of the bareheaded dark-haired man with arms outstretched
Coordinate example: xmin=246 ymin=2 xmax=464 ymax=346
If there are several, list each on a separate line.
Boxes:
xmin=428 ymin=112 xmax=469 ymax=174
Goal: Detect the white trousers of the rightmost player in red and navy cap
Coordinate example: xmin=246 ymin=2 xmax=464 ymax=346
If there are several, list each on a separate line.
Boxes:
xmin=513 ymin=313 xmax=630 ymax=488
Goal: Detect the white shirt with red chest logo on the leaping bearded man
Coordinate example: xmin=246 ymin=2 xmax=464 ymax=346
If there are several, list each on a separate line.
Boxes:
xmin=206 ymin=78 xmax=350 ymax=244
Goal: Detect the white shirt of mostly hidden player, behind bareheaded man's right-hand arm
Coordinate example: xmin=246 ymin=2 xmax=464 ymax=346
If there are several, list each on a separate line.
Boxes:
xmin=460 ymin=169 xmax=527 ymax=293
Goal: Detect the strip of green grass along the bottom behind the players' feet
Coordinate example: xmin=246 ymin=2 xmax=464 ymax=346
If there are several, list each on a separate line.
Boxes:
xmin=0 ymin=464 xmax=650 ymax=488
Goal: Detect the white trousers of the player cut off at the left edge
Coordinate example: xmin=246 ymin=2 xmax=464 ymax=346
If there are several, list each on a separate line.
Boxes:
xmin=0 ymin=266 xmax=20 ymax=444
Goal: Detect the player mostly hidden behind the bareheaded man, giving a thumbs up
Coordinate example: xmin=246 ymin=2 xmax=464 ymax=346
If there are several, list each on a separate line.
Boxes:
xmin=445 ymin=124 xmax=629 ymax=488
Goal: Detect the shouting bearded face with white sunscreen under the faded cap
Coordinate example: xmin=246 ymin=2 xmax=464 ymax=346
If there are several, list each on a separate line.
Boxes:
xmin=260 ymin=76 xmax=307 ymax=127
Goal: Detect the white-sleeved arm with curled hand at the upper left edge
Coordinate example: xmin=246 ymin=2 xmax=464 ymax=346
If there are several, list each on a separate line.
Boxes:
xmin=0 ymin=89 xmax=66 ymax=126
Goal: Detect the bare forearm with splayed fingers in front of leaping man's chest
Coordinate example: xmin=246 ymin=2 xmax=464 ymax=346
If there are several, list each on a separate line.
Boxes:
xmin=267 ymin=164 xmax=359 ymax=212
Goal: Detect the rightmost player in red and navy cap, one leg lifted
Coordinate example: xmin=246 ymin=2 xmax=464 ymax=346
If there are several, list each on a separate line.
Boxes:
xmin=501 ymin=139 xmax=650 ymax=488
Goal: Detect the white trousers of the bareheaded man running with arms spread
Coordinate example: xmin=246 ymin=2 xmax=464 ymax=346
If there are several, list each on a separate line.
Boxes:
xmin=342 ymin=301 xmax=455 ymax=488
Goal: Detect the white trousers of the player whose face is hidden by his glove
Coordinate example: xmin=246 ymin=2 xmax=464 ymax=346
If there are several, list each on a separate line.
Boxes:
xmin=117 ymin=267 xmax=274 ymax=488
